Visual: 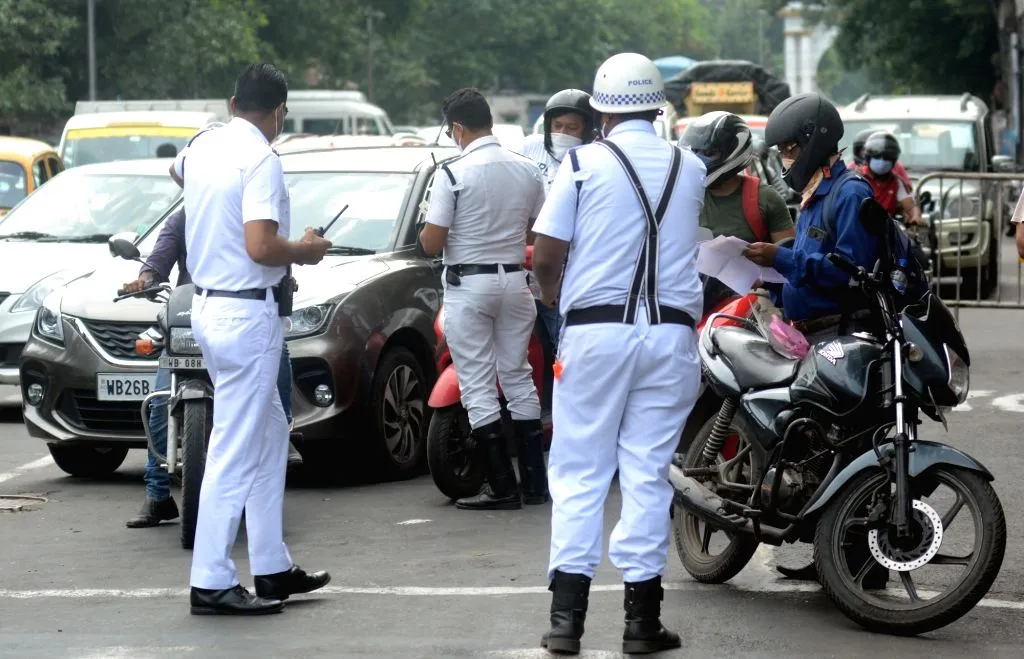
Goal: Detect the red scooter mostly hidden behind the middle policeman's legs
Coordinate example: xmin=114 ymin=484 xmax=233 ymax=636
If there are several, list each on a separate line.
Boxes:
xmin=427 ymin=246 xmax=551 ymax=499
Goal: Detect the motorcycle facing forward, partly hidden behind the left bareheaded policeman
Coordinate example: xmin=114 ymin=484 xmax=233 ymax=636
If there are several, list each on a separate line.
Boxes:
xmin=110 ymin=238 xmax=213 ymax=550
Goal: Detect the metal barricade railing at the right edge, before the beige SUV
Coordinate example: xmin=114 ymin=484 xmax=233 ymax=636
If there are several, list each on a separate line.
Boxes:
xmin=914 ymin=172 xmax=1024 ymax=318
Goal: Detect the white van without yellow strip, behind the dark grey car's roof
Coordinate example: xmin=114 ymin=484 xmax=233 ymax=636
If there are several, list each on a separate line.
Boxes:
xmin=284 ymin=89 xmax=394 ymax=135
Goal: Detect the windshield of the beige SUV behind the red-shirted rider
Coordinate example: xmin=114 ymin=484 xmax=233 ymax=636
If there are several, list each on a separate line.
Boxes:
xmin=840 ymin=119 xmax=979 ymax=172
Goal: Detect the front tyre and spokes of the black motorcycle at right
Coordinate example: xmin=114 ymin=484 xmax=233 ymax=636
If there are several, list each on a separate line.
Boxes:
xmin=814 ymin=466 xmax=1007 ymax=635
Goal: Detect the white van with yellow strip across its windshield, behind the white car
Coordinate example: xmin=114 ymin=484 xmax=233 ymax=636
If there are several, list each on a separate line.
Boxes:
xmin=57 ymin=99 xmax=229 ymax=169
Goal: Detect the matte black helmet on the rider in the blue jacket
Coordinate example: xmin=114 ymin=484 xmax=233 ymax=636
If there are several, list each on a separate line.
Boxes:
xmin=765 ymin=93 xmax=843 ymax=192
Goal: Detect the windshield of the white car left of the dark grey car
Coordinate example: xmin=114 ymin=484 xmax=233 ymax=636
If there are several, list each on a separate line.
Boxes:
xmin=0 ymin=171 xmax=181 ymax=243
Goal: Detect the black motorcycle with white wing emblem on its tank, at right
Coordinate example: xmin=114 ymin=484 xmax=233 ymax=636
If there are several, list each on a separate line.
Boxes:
xmin=670 ymin=200 xmax=1007 ymax=634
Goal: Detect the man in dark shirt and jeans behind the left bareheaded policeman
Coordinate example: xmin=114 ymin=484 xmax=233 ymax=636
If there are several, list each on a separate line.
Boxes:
xmin=124 ymin=207 xmax=302 ymax=528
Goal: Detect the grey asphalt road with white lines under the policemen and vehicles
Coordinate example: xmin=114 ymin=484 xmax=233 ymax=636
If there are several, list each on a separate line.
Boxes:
xmin=0 ymin=309 xmax=1024 ymax=659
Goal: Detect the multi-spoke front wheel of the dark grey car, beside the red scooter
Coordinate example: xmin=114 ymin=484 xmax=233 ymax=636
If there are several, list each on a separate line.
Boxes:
xmin=371 ymin=347 xmax=428 ymax=478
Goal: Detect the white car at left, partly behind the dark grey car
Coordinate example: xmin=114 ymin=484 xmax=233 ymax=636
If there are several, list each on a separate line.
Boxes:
xmin=0 ymin=159 xmax=181 ymax=404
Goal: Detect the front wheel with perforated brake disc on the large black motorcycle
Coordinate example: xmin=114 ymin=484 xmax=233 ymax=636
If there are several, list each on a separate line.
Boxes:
xmin=814 ymin=466 xmax=1007 ymax=635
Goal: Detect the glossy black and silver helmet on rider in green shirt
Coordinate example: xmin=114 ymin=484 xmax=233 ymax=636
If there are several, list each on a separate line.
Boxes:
xmin=679 ymin=111 xmax=754 ymax=187
